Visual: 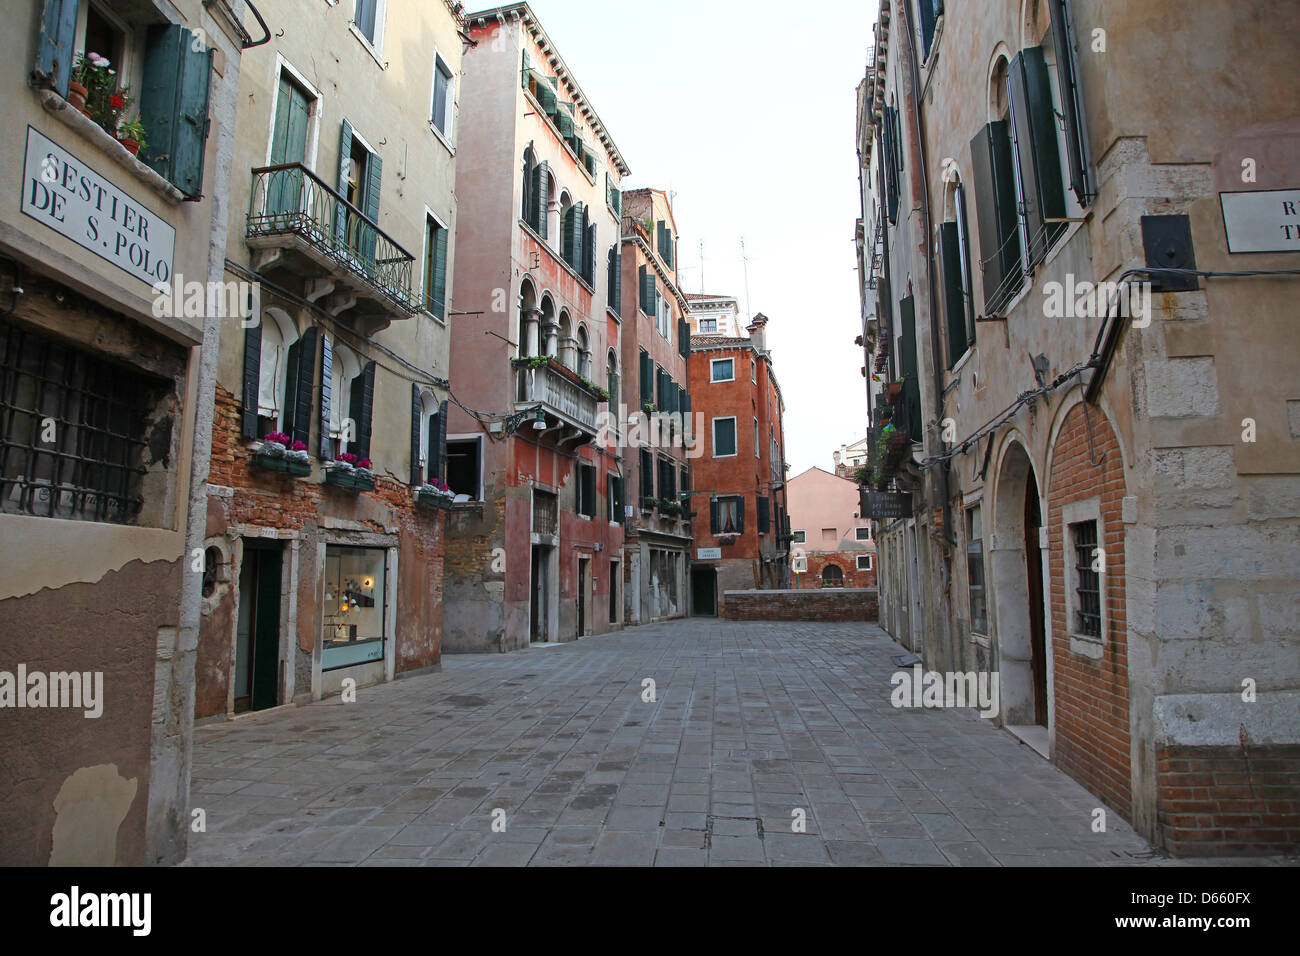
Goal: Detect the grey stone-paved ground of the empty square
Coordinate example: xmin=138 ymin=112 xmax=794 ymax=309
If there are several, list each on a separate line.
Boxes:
xmin=187 ymin=618 xmax=1248 ymax=866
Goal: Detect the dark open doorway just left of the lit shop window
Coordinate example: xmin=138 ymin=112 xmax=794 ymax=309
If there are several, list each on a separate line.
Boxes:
xmin=234 ymin=540 xmax=283 ymax=714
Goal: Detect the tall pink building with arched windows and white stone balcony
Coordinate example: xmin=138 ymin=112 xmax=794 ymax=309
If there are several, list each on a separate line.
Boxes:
xmin=443 ymin=3 xmax=629 ymax=653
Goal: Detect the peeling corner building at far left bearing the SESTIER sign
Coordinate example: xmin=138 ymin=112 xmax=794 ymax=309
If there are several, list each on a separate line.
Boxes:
xmin=0 ymin=0 xmax=245 ymax=866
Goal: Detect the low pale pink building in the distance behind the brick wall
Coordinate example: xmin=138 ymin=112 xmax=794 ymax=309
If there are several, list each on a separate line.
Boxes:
xmin=788 ymin=468 xmax=876 ymax=588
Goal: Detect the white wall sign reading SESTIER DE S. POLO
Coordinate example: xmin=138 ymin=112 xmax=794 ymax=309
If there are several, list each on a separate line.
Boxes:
xmin=22 ymin=126 xmax=176 ymax=286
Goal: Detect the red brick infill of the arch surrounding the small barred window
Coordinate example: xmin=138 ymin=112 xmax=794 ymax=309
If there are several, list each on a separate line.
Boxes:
xmin=1047 ymin=405 xmax=1132 ymax=819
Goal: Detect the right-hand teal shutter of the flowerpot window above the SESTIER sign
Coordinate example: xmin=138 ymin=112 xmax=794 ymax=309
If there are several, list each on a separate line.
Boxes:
xmin=140 ymin=23 xmax=212 ymax=199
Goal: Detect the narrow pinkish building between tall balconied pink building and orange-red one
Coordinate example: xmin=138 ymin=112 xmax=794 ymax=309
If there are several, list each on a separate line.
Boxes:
xmin=619 ymin=189 xmax=699 ymax=624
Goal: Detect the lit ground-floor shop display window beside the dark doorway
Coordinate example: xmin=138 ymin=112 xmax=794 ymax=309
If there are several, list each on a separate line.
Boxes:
xmin=321 ymin=545 xmax=387 ymax=670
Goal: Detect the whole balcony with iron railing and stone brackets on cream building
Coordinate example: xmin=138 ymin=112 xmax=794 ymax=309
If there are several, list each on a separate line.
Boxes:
xmin=246 ymin=163 xmax=419 ymax=336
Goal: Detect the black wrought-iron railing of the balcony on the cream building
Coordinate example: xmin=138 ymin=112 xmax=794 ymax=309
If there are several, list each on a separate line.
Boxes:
xmin=247 ymin=163 xmax=419 ymax=312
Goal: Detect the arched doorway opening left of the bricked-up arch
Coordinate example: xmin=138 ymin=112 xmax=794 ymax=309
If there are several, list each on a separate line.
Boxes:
xmin=989 ymin=441 xmax=1048 ymax=733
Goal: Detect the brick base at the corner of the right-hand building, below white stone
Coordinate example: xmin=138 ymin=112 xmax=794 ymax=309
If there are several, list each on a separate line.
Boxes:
xmin=1156 ymin=744 xmax=1300 ymax=856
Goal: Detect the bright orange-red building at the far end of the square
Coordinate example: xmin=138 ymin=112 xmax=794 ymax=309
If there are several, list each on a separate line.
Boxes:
xmin=689 ymin=313 xmax=790 ymax=614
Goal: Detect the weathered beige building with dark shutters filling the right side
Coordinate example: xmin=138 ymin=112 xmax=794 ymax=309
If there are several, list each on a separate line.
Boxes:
xmin=858 ymin=0 xmax=1300 ymax=853
